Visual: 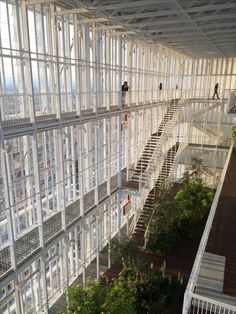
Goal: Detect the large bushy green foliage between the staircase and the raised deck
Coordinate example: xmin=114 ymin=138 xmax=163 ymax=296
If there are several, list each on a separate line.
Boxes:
xmin=146 ymin=177 xmax=214 ymax=255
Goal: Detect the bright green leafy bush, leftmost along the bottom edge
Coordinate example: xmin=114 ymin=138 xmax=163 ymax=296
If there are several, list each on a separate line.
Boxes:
xmin=68 ymin=282 xmax=106 ymax=314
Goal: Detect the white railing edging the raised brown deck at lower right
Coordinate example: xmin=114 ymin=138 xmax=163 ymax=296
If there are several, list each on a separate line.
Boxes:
xmin=182 ymin=143 xmax=235 ymax=314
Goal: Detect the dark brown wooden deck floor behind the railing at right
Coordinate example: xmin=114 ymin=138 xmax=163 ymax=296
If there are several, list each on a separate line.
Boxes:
xmin=206 ymin=148 xmax=236 ymax=297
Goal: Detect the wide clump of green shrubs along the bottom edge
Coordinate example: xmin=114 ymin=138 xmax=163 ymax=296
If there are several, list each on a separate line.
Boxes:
xmin=69 ymin=267 xmax=184 ymax=314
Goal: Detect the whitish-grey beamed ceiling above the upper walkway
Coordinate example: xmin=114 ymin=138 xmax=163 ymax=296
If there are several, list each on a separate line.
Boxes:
xmin=64 ymin=0 xmax=236 ymax=58
